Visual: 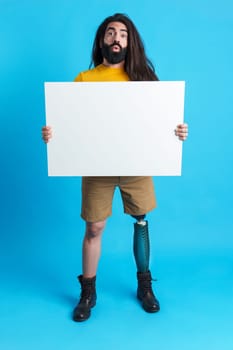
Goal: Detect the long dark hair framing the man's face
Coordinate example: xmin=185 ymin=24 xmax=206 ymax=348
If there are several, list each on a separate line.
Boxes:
xmin=90 ymin=13 xmax=159 ymax=81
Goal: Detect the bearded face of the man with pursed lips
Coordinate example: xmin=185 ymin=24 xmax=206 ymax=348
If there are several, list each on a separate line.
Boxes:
xmin=102 ymin=22 xmax=128 ymax=64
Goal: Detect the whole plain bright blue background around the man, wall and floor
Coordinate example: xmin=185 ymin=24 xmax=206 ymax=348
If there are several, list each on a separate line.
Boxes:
xmin=0 ymin=0 xmax=233 ymax=350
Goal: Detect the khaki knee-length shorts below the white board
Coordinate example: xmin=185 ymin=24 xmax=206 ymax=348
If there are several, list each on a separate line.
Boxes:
xmin=81 ymin=176 xmax=156 ymax=222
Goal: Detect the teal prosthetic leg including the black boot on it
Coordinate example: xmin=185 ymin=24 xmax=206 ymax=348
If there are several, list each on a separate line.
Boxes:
xmin=133 ymin=215 xmax=160 ymax=313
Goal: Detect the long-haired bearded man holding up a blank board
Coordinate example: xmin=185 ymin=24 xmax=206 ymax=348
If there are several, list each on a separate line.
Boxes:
xmin=42 ymin=14 xmax=188 ymax=322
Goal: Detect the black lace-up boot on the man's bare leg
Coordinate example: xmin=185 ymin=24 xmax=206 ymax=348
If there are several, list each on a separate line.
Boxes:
xmin=73 ymin=275 xmax=97 ymax=322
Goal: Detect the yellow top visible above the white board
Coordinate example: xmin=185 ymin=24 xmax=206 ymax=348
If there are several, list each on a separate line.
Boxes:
xmin=74 ymin=64 xmax=129 ymax=82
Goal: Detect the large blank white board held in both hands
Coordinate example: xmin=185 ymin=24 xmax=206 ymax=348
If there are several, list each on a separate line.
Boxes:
xmin=45 ymin=81 xmax=185 ymax=176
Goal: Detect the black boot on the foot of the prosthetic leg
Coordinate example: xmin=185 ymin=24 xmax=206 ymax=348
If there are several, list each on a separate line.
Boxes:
xmin=137 ymin=271 xmax=160 ymax=312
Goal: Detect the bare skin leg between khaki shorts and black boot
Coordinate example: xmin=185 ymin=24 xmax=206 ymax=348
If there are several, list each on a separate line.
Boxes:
xmin=83 ymin=221 xmax=106 ymax=278
